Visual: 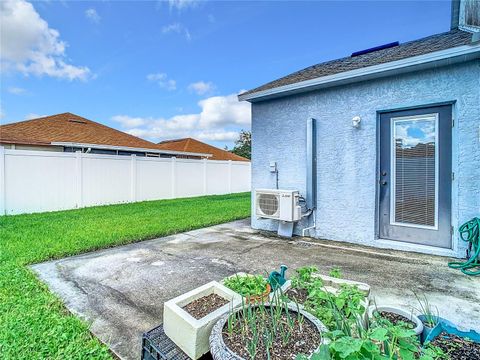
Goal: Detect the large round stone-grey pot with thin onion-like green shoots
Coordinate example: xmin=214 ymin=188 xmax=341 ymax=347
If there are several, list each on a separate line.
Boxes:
xmin=210 ymin=297 xmax=327 ymax=360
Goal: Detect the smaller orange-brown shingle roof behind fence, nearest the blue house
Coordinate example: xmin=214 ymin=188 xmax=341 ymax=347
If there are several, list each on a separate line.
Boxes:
xmin=157 ymin=138 xmax=250 ymax=161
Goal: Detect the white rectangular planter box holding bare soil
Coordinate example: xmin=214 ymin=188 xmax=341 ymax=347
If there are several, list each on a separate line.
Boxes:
xmin=163 ymin=281 xmax=242 ymax=360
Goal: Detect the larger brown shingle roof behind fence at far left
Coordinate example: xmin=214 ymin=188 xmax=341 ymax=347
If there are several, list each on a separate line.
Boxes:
xmin=0 ymin=113 xmax=161 ymax=149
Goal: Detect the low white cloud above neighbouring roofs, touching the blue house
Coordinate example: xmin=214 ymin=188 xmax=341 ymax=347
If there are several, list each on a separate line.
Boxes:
xmin=112 ymin=94 xmax=250 ymax=141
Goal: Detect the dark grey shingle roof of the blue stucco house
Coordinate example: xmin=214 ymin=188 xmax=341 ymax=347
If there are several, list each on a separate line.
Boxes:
xmin=239 ymin=29 xmax=479 ymax=100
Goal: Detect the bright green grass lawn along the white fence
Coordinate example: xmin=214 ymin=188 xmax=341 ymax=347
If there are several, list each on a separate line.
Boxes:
xmin=0 ymin=193 xmax=250 ymax=359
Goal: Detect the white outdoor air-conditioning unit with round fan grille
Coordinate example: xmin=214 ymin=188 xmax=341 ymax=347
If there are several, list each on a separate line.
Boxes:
xmin=255 ymin=189 xmax=302 ymax=222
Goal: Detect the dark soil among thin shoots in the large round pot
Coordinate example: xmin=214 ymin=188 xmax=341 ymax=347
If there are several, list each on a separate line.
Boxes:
xmin=223 ymin=312 xmax=321 ymax=360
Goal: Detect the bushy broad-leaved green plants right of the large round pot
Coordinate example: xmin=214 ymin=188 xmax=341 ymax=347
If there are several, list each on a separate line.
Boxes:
xmin=292 ymin=267 xmax=448 ymax=360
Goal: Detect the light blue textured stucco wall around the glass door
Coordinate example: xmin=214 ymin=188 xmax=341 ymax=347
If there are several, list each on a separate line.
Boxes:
xmin=252 ymin=60 xmax=480 ymax=257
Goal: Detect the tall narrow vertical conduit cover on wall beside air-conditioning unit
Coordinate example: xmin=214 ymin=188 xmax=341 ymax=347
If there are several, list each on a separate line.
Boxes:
xmin=302 ymin=118 xmax=317 ymax=236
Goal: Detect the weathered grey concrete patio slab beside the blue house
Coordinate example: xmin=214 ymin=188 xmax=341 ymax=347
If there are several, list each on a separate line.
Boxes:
xmin=32 ymin=220 xmax=480 ymax=359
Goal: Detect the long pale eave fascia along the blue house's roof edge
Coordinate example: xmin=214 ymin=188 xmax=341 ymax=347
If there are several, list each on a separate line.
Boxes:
xmin=238 ymin=43 xmax=480 ymax=103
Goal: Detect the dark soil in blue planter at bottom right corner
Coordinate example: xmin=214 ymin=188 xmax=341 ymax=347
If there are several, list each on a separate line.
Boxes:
xmin=431 ymin=332 xmax=480 ymax=360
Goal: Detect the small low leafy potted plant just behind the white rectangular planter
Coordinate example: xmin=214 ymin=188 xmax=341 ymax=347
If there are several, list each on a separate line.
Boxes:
xmin=223 ymin=273 xmax=271 ymax=303
